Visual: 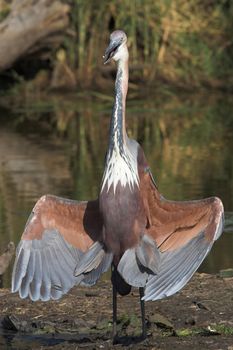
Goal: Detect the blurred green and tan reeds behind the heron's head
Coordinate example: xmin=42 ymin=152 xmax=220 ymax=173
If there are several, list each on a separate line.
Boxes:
xmin=61 ymin=0 xmax=233 ymax=89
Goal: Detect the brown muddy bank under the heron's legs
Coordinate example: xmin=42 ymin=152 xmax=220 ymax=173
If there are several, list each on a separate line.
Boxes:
xmin=0 ymin=274 xmax=233 ymax=350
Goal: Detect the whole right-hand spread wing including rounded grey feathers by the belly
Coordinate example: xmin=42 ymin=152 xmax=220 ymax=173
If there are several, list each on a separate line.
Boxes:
xmin=118 ymin=171 xmax=224 ymax=300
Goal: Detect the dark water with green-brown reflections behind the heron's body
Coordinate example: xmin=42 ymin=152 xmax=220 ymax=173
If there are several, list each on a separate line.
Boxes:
xmin=0 ymin=89 xmax=233 ymax=287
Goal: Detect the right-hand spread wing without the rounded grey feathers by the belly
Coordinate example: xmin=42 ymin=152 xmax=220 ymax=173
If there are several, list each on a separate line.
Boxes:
xmin=145 ymin=174 xmax=224 ymax=300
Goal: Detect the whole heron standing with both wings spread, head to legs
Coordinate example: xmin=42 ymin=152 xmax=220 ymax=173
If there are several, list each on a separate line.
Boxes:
xmin=12 ymin=30 xmax=223 ymax=336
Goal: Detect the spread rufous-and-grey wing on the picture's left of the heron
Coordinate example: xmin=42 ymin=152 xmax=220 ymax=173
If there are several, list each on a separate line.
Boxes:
xmin=12 ymin=195 xmax=111 ymax=301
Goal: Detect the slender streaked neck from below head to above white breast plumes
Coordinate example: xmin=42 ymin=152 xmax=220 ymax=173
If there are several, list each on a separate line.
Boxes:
xmin=109 ymin=57 xmax=129 ymax=152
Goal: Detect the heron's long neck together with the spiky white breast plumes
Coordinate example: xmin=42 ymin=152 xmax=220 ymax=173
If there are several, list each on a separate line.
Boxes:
xmin=101 ymin=47 xmax=139 ymax=193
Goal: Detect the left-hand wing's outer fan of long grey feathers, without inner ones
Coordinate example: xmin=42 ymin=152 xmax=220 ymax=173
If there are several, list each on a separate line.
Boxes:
xmin=12 ymin=230 xmax=83 ymax=301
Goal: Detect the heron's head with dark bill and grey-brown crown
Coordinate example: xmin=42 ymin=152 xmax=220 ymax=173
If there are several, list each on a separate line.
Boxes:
xmin=103 ymin=30 xmax=128 ymax=64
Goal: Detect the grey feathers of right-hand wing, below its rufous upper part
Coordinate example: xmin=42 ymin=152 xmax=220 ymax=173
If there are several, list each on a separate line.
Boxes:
xmin=117 ymin=233 xmax=217 ymax=301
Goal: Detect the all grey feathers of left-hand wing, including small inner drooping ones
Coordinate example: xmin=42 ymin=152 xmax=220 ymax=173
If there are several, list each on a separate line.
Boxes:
xmin=12 ymin=229 xmax=112 ymax=301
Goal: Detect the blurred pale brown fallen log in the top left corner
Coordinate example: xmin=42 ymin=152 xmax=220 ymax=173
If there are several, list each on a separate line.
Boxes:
xmin=0 ymin=0 xmax=70 ymax=72
